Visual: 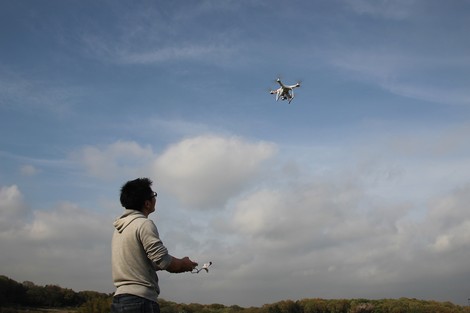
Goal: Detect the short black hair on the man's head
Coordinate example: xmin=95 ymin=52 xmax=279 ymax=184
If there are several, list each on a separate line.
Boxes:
xmin=120 ymin=178 xmax=153 ymax=211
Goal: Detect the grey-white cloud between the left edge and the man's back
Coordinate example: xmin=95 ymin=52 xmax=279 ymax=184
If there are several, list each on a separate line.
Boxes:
xmin=0 ymin=186 xmax=112 ymax=291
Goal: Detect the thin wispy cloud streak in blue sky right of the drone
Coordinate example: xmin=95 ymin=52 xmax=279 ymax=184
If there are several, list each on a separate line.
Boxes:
xmin=323 ymin=43 xmax=470 ymax=105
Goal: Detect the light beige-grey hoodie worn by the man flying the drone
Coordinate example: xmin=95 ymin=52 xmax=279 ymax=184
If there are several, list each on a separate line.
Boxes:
xmin=111 ymin=210 xmax=172 ymax=301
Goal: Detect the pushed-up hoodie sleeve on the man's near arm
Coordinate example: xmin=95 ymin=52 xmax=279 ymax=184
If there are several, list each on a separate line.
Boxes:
xmin=139 ymin=219 xmax=172 ymax=270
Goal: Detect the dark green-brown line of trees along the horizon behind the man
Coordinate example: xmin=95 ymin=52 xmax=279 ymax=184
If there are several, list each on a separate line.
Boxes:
xmin=0 ymin=276 xmax=470 ymax=313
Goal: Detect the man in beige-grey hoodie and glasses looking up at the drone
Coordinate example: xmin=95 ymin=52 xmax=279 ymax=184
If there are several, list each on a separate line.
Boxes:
xmin=111 ymin=178 xmax=197 ymax=313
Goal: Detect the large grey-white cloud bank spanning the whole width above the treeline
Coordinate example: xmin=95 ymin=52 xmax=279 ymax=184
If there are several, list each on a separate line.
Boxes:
xmin=0 ymin=135 xmax=470 ymax=305
